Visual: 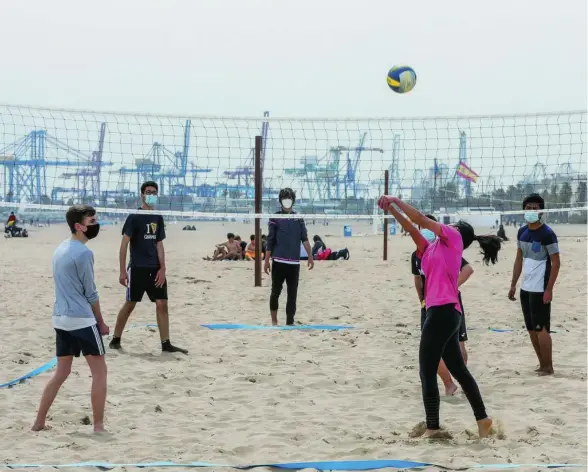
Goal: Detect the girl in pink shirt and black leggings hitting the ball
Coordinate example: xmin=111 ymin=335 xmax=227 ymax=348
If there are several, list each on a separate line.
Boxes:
xmin=378 ymin=195 xmax=501 ymax=438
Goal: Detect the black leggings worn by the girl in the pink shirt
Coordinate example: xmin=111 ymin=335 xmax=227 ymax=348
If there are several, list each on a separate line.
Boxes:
xmin=419 ymin=304 xmax=487 ymax=429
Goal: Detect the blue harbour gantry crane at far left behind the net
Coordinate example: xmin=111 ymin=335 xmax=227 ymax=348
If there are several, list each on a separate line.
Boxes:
xmin=0 ymin=126 xmax=112 ymax=203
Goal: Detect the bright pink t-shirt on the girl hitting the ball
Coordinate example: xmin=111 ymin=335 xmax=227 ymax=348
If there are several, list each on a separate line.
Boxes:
xmin=421 ymin=225 xmax=463 ymax=313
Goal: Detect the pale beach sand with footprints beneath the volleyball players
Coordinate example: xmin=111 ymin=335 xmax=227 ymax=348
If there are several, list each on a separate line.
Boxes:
xmin=0 ymin=222 xmax=587 ymax=470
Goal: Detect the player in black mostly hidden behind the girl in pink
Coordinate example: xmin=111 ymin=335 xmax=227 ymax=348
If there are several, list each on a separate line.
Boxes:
xmin=410 ymin=215 xmax=474 ymax=396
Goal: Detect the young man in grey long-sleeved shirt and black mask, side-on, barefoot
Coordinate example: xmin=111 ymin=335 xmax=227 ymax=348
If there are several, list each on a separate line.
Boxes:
xmin=32 ymin=205 xmax=109 ymax=432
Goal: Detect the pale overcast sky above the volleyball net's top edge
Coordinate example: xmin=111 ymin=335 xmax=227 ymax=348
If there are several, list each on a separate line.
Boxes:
xmin=0 ymin=0 xmax=587 ymax=117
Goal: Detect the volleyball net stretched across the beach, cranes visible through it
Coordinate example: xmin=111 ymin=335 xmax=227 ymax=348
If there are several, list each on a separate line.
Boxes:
xmin=0 ymin=105 xmax=587 ymax=222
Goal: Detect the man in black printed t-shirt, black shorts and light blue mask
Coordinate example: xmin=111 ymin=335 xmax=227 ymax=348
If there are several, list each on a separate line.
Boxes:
xmin=110 ymin=181 xmax=188 ymax=354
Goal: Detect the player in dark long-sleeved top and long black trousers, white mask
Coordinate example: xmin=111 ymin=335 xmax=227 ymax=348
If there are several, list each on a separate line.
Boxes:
xmin=264 ymin=188 xmax=314 ymax=326
